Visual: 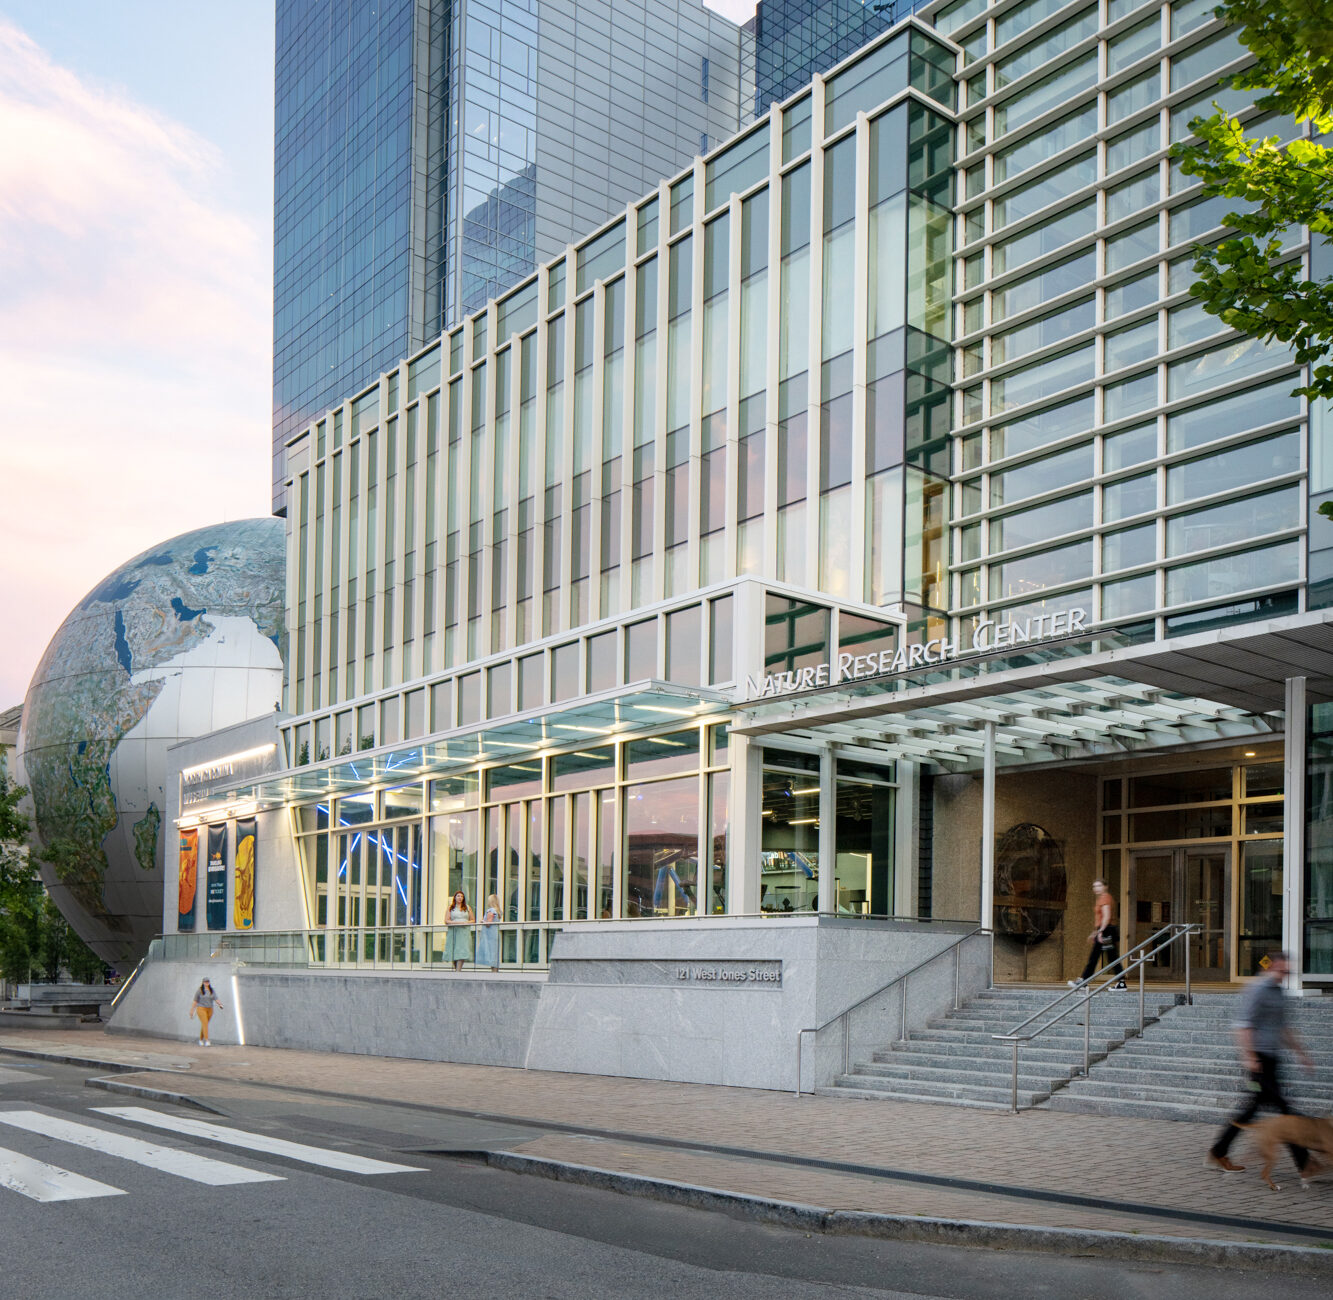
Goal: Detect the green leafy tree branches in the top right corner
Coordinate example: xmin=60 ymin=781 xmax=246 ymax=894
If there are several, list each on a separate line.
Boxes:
xmin=1172 ymin=0 xmax=1333 ymax=400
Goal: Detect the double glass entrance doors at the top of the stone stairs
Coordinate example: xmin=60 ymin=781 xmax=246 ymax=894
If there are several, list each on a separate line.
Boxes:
xmin=1125 ymin=845 xmax=1232 ymax=980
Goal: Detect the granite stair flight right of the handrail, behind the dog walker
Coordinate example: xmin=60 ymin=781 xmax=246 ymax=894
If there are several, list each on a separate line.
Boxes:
xmin=1049 ymin=993 xmax=1333 ymax=1124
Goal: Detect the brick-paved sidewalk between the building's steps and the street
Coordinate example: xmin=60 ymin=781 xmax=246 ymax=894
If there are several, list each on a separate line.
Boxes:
xmin=0 ymin=1028 xmax=1333 ymax=1248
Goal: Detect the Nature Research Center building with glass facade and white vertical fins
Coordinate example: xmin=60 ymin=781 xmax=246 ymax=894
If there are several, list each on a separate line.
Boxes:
xmin=117 ymin=0 xmax=1333 ymax=1087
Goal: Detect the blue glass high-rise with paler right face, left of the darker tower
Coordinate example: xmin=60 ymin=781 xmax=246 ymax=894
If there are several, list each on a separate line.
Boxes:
xmin=273 ymin=0 xmax=749 ymax=509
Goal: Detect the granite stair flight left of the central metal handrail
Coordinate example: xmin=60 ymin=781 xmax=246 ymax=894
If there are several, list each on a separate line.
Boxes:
xmin=817 ymin=988 xmax=1176 ymax=1108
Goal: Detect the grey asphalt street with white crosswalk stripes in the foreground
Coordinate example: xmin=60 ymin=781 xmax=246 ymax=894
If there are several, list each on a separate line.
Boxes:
xmin=0 ymin=1053 xmax=1328 ymax=1300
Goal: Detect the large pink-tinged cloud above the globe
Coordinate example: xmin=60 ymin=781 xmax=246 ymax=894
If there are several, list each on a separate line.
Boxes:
xmin=0 ymin=20 xmax=272 ymax=707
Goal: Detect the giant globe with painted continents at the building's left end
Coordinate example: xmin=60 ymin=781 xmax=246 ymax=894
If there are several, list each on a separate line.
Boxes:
xmin=19 ymin=519 xmax=285 ymax=965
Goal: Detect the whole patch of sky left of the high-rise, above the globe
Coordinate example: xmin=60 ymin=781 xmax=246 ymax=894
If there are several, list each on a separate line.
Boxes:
xmin=0 ymin=0 xmax=273 ymax=708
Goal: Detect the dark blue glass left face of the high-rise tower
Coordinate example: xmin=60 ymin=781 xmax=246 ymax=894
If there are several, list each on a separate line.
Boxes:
xmin=273 ymin=0 xmax=413 ymax=514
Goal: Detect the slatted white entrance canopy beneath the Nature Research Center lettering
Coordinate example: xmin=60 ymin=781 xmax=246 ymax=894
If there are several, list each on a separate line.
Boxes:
xmin=732 ymin=612 xmax=1333 ymax=772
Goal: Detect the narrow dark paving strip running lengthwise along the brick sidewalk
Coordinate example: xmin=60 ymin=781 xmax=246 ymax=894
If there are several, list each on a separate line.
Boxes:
xmin=12 ymin=1040 xmax=1333 ymax=1256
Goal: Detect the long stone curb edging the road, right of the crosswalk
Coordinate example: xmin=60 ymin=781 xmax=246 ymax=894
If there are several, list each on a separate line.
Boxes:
xmin=479 ymin=1151 xmax=1333 ymax=1279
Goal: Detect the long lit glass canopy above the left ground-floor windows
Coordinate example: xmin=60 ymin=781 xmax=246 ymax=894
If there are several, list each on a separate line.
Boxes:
xmin=215 ymin=681 xmax=730 ymax=812
